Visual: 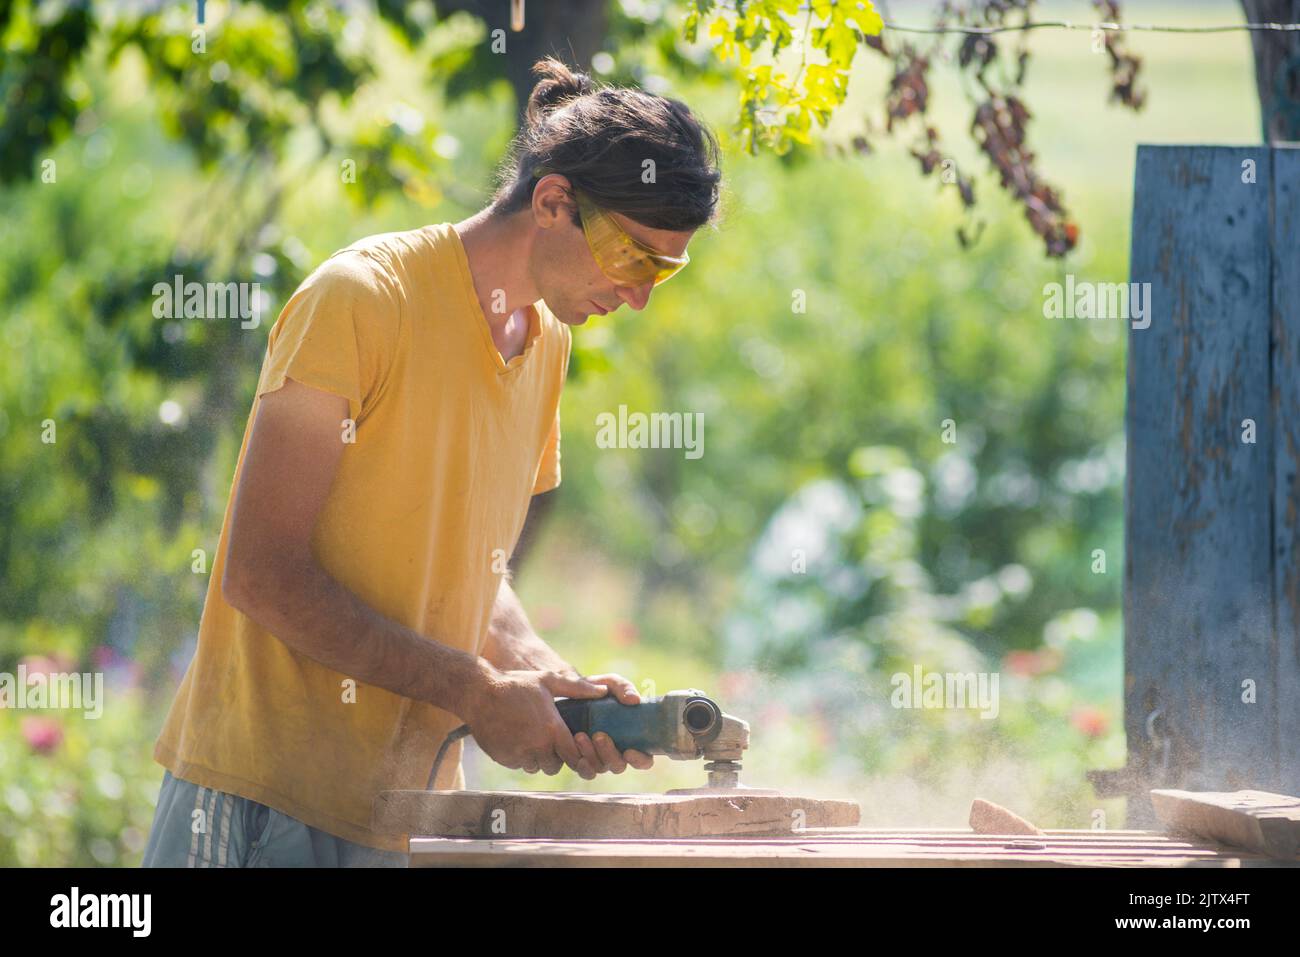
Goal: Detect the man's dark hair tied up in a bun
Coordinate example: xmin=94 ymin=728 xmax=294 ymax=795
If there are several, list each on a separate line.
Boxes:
xmin=493 ymin=57 xmax=722 ymax=231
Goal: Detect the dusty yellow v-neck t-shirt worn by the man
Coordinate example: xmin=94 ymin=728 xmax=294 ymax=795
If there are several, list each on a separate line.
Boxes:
xmin=153 ymin=224 xmax=571 ymax=850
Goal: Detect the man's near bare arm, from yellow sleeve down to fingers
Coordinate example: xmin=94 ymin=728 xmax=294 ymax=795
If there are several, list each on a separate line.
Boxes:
xmin=221 ymin=380 xmax=606 ymax=776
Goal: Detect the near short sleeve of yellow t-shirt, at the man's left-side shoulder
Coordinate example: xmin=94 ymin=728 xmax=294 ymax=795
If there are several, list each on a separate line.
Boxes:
xmin=257 ymin=252 xmax=402 ymax=421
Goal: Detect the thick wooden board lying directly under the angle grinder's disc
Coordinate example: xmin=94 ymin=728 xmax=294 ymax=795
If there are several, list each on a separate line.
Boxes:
xmin=373 ymin=791 xmax=861 ymax=839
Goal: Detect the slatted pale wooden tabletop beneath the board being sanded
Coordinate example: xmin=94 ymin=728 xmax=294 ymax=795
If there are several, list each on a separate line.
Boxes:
xmin=411 ymin=828 xmax=1278 ymax=867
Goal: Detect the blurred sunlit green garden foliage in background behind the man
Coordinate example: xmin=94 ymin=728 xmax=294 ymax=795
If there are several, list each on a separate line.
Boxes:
xmin=0 ymin=3 xmax=1255 ymax=865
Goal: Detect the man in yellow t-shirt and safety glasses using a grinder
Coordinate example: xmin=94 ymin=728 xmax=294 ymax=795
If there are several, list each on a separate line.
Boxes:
xmin=144 ymin=60 xmax=720 ymax=866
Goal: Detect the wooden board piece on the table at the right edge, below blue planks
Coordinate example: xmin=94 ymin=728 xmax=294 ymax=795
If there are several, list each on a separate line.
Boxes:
xmin=1151 ymin=791 xmax=1300 ymax=861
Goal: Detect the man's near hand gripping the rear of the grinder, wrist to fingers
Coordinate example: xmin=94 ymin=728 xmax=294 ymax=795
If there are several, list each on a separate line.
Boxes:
xmin=462 ymin=668 xmax=607 ymax=780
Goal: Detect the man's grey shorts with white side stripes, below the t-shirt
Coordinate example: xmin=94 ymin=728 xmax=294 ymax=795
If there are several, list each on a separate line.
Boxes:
xmin=142 ymin=771 xmax=411 ymax=867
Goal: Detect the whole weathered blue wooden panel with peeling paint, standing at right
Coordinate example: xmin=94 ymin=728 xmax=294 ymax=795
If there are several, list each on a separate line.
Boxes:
xmin=1093 ymin=146 xmax=1300 ymax=827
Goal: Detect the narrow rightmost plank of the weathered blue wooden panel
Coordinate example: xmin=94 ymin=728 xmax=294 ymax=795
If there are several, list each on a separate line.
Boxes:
xmin=1255 ymin=147 xmax=1300 ymax=794
